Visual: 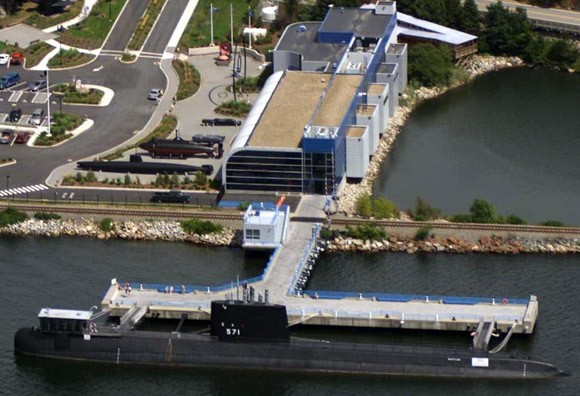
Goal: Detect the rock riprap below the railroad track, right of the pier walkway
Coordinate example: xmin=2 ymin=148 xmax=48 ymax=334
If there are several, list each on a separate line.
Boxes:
xmin=327 ymin=236 xmax=580 ymax=254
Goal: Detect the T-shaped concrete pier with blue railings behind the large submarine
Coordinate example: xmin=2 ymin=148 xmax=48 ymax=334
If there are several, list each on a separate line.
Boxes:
xmin=101 ymin=215 xmax=538 ymax=334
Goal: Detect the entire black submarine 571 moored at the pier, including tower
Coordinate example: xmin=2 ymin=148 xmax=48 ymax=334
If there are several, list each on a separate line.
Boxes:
xmin=14 ymin=300 xmax=565 ymax=380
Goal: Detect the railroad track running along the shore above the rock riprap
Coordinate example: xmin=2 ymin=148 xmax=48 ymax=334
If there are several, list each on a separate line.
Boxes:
xmin=0 ymin=203 xmax=580 ymax=236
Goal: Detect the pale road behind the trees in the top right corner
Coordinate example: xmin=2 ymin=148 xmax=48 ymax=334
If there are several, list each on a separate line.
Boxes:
xmin=475 ymin=0 xmax=580 ymax=34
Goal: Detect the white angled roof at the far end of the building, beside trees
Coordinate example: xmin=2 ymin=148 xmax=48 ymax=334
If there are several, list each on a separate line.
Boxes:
xmin=395 ymin=12 xmax=477 ymax=45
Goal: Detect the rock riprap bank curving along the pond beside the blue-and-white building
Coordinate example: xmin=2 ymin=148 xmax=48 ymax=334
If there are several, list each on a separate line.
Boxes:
xmin=339 ymin=55 xmax=524 ymax=215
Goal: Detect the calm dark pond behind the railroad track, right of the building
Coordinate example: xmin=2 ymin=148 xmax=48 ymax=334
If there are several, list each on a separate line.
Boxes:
xmin=374 ymin=69 xmax=580 ymax=225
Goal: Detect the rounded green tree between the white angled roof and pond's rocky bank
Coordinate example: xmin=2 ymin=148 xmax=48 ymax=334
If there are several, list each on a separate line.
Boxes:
xmin=408 ymin=43 xmax=455 ymax=87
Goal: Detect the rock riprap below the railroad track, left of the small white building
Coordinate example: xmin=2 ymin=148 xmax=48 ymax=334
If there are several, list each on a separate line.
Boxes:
xmin=1 ymin=219 xmax=241 ymax=247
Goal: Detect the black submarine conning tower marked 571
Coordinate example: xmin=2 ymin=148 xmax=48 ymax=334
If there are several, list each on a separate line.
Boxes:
xmin=211 ymin=300 xmax=290 ymax=342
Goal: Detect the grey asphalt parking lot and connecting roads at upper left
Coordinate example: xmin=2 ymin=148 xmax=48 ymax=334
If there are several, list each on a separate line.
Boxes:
xmin=0 ymin=0 xmax=195 ymax=207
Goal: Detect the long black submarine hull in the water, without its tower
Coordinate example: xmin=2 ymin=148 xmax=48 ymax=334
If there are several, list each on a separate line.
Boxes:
xmin=14 ymin=328 xmax=562 ymax=379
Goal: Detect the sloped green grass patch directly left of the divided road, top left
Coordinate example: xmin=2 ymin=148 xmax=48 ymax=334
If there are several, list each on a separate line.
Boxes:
xmin=58 ymin=0 xmax=127 ymax=49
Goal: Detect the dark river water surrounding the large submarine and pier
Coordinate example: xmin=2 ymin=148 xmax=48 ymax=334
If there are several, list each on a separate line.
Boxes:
xmin=0 ymin=238 xmax=580 ymax=395
